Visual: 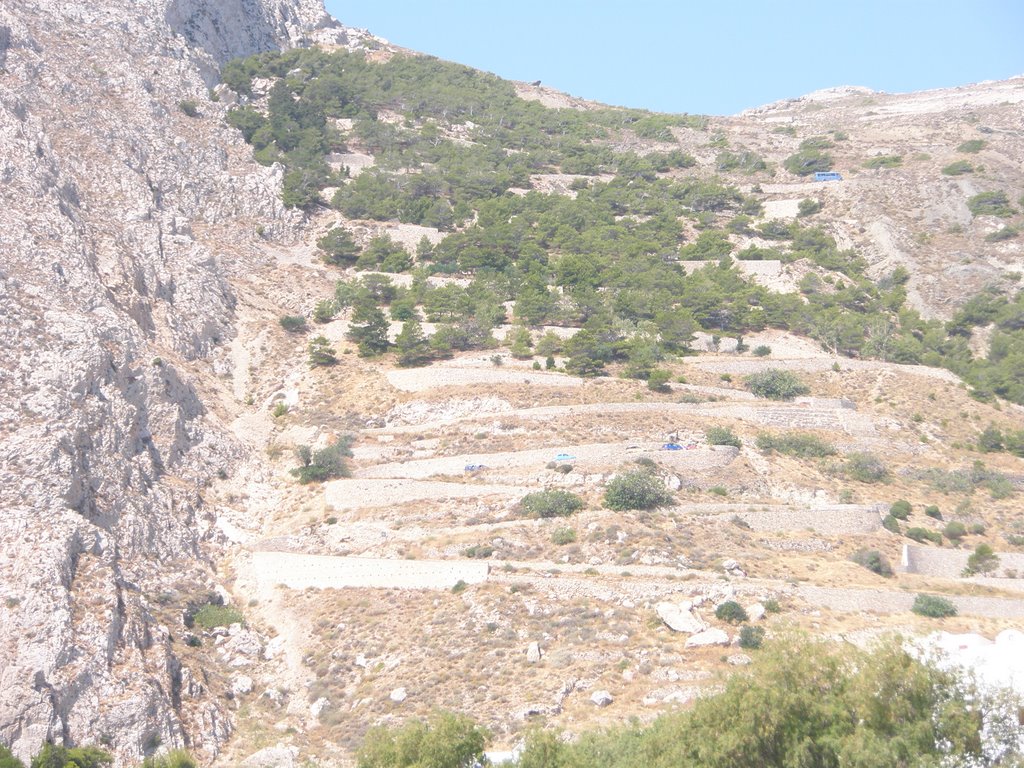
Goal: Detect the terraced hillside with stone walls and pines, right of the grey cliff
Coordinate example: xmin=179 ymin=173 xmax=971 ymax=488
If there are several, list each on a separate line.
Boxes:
xmin=178 ymin=40 xmax=1024 ymax=765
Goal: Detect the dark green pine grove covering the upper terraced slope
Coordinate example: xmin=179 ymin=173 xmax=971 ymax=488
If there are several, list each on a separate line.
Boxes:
xmin=230 ymin=50 xmax=1024 ymax=402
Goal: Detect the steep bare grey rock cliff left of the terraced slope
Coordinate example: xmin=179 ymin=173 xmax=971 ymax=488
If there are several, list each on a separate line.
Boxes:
xmin=0 ymin=0 xmax=345 ymax=763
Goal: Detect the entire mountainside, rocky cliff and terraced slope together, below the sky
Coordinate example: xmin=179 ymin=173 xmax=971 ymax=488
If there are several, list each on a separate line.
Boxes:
xmin=0 ymin=0 xmax=1024 ymax=767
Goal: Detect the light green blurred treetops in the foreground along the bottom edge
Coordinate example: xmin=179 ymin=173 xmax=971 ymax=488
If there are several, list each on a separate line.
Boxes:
xmin=357 ymin=638 xmax=1024 ymax=768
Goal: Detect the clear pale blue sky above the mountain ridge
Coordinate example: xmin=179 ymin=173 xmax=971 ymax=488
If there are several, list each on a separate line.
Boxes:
xmin=326 ymin=0 xmax=1024 ymax=115
